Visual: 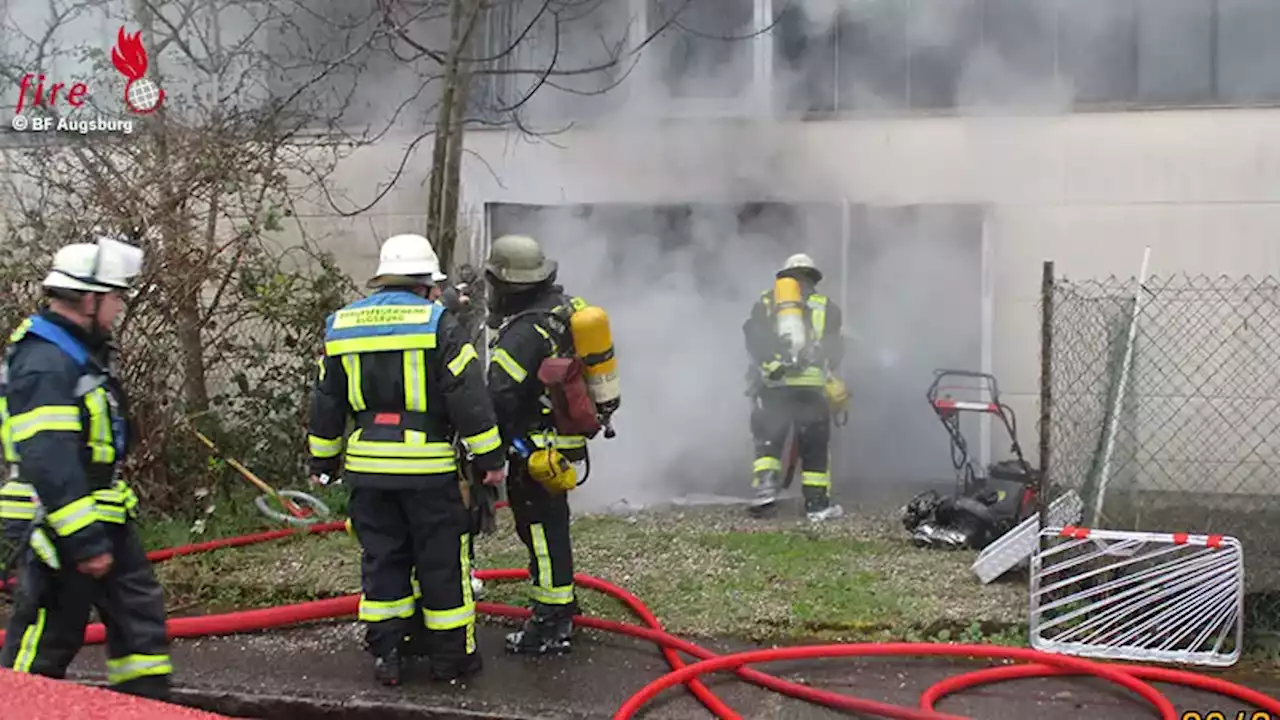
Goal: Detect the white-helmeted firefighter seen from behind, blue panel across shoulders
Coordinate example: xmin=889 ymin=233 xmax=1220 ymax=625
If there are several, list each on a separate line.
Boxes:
xmin=307 ymin=234 xmax=504 ymax=685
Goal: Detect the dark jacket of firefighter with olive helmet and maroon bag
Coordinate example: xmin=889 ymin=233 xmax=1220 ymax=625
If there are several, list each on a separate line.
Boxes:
xmin=489 ymin=288 xmax=586 ymax=462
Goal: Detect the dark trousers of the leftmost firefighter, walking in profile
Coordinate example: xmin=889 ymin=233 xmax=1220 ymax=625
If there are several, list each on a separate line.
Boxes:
xmin=0 ymin=523 xmax=173 ymax=700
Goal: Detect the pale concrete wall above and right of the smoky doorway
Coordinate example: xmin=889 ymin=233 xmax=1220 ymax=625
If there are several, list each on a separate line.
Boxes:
xmin=432 ymin=110 xmax=1280 ymax=486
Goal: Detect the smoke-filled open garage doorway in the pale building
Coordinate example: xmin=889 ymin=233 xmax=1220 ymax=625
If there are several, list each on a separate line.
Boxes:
xmin=485 ymin=202 xmax=984 ymax=509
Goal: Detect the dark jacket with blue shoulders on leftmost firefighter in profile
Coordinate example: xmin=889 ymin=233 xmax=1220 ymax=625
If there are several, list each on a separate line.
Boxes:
xmin=0 ymin=310 xmax=138 ymax=568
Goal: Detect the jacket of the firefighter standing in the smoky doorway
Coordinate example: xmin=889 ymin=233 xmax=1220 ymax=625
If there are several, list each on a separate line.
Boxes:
xmin=742 ymin=288 xmax=845 ymax=388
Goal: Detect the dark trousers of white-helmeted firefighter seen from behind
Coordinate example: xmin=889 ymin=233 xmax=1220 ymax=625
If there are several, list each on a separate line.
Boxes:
xmin=347 ymin=474 xmax=476 ymax=673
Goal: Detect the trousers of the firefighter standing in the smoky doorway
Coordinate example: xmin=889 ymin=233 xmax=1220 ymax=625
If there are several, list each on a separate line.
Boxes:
xmin=751 ymin=387 xmax=831 ymax=512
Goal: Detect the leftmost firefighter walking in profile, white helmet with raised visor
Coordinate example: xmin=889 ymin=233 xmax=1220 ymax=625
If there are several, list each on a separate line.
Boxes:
xmin=0 ymin=237 xmax=173 ymax=700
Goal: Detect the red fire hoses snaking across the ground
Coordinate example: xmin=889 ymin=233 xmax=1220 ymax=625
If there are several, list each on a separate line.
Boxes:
xmin=0 ymin=509 xmax=1280 ymax=720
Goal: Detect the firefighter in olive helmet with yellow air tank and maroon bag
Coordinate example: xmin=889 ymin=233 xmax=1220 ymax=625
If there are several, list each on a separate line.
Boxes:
xmin=485 ymin=236 xmax=618 ymax=655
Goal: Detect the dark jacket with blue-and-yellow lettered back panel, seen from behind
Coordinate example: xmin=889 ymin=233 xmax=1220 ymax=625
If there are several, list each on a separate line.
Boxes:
xmin=307 ymin=290 xmax=506 ymax=489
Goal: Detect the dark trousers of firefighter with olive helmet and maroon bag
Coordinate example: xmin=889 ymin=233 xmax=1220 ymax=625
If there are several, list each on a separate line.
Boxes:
xmin=507 ymin=457 xmax=577 ymax=620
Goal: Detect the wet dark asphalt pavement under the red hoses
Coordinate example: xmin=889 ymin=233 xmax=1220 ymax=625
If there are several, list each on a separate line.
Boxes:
xmin=64 ymin=623 xmax=1263 ymax=720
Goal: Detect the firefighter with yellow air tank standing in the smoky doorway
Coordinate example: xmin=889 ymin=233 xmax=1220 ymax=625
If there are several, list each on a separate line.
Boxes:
xmin=742 ymin=254 xmax=847 ymax=521
